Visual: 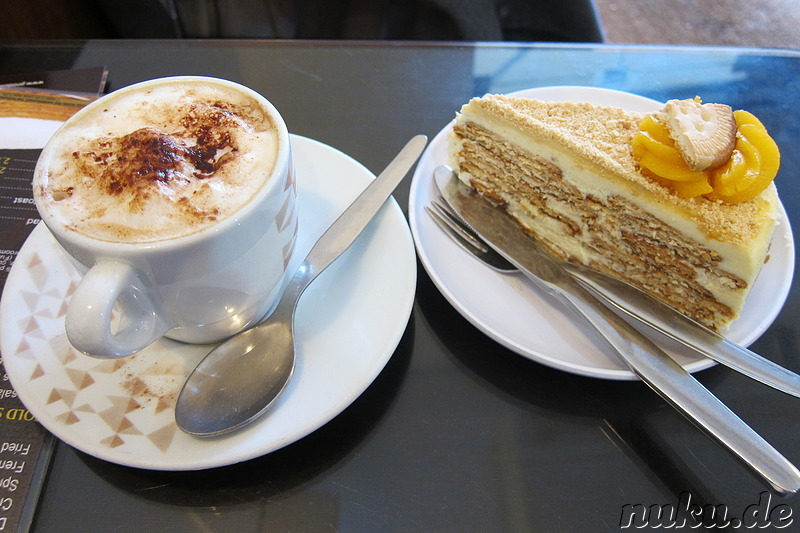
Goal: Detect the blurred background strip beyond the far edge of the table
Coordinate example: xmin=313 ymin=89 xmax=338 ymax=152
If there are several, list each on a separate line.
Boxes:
xmin=0 ymin=0 xmax=800 ymax=49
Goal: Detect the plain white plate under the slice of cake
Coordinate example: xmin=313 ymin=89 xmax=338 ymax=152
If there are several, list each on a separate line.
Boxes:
xmin=409 ymin=87 xmax=794 ymax=380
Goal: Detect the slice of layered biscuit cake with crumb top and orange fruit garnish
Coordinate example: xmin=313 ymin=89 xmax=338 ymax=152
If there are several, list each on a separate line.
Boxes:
xmin=449 ymin=95 xmax=779 ymax=331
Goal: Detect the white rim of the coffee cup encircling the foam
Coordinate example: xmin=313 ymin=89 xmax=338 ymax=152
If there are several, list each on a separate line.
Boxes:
xmin=33 ymin=75 xmax=293 ymax=254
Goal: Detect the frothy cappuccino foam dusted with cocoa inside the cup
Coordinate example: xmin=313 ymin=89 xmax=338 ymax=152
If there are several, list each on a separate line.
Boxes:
xmin=34 ymin=80 xmax=279 ymax=243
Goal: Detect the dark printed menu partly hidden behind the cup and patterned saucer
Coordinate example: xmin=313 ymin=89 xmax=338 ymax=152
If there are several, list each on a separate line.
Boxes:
xmin=0 ymin=68 xmax=105 ymax=532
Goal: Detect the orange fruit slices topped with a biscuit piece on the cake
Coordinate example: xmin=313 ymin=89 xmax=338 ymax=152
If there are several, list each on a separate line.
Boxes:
xmin=632 ymin=97 xmax=780 ymax=204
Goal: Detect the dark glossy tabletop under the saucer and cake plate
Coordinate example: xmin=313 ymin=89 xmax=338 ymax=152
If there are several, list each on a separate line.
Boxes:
xmin=0 ymin=41 xmax=800 ymax=532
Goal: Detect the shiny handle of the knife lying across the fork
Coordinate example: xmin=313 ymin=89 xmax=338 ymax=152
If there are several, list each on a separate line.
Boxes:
xmin=559 ymin=285 xmax=800 ymax=494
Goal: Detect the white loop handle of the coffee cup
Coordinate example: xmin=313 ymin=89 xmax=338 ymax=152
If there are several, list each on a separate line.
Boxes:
xmin=65 ymin=261 xmax=170 ymax=358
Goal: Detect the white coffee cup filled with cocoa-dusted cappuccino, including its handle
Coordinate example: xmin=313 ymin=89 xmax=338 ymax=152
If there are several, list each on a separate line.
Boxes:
xmin=33 ymin=76 xmax=297 ymax=357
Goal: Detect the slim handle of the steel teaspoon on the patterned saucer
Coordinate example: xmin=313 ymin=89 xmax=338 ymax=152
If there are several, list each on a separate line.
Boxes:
xmin=280 ymin=135 xmax=428 ymax=298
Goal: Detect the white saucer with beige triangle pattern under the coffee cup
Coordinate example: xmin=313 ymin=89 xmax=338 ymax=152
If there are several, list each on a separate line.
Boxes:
xmin=0 ymin=136 xmax=416 ymax=470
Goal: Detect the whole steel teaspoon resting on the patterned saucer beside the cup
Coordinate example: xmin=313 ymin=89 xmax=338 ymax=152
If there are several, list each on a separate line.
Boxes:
xmin=175 ymin=135 xmax=427 ymax=437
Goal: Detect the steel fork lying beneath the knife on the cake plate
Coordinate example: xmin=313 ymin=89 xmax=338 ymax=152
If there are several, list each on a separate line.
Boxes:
xmin=425 ymin=193 xmax=800 ymax=397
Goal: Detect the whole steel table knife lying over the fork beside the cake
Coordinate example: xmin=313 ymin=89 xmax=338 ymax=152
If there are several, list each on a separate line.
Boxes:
xmin=436 ymin=169 xmax=800 ymax=494
